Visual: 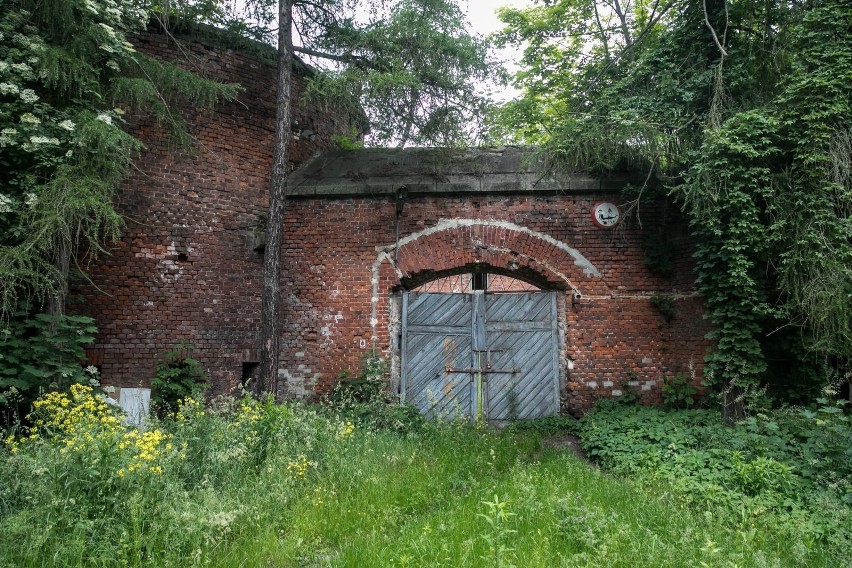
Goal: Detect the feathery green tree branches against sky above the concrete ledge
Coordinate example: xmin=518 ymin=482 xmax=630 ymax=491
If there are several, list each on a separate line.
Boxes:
xmin=172 ymin=0 xmax=504 ymax=146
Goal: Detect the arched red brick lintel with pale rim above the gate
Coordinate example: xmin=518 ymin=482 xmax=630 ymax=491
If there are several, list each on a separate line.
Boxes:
xmin=388 ymin=219 xmax=605 ymax=294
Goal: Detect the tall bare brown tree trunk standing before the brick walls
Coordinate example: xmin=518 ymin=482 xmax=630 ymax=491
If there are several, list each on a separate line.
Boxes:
xmin=255 ymin=0 xmax=293 ymax=398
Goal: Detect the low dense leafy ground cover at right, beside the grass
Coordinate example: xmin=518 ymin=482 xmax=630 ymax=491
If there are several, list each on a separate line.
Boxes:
xmin=582 ymin=400 xmax=852 ymax=553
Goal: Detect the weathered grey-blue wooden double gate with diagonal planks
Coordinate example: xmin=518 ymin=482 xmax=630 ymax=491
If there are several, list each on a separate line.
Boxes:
xmin=401 ymin=292 xmax=559 ymax=421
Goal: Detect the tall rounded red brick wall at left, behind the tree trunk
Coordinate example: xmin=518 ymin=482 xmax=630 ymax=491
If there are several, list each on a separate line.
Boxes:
xmin=72 ymin=34 xmax=362 ymax=391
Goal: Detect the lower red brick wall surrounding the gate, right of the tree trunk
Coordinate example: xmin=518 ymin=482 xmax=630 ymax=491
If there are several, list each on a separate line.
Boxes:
xmin=282 ymin=194 xmax=709 ymax=412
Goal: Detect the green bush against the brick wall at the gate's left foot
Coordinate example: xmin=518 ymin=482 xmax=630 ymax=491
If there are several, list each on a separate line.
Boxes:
xmin=325 ymin=352 xmax=423 ymax=432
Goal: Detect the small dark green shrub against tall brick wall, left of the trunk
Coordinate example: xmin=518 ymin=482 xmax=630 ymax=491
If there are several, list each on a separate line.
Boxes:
xmin=151 ymin=346 xmax=207 ymax=419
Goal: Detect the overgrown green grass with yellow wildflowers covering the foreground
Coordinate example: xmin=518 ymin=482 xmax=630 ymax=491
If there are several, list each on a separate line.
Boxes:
xmin=0 ymin=388 xmax=842 ymax=568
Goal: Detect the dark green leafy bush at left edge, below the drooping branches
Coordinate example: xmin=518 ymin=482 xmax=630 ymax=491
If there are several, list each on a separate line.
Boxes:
xmin=0 ymin=309 xmax=98 ymax=426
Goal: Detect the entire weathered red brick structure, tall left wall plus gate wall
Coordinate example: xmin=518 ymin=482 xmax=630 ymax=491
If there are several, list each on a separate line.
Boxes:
xmin=76 ymin=32 xmax=708 ymax=412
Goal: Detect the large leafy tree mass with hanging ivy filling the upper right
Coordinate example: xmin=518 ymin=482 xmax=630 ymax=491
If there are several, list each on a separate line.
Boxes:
xmin=495 ymin=0 xmax=852 ymax=415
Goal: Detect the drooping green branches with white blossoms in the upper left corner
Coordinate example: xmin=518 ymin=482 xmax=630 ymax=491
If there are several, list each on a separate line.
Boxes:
xmin=0 ymin=0 xmax=238 ymax=315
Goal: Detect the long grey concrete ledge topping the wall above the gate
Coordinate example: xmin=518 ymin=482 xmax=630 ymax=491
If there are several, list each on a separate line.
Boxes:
xmin=287 ymin=146 xmax=644 ymax=197
